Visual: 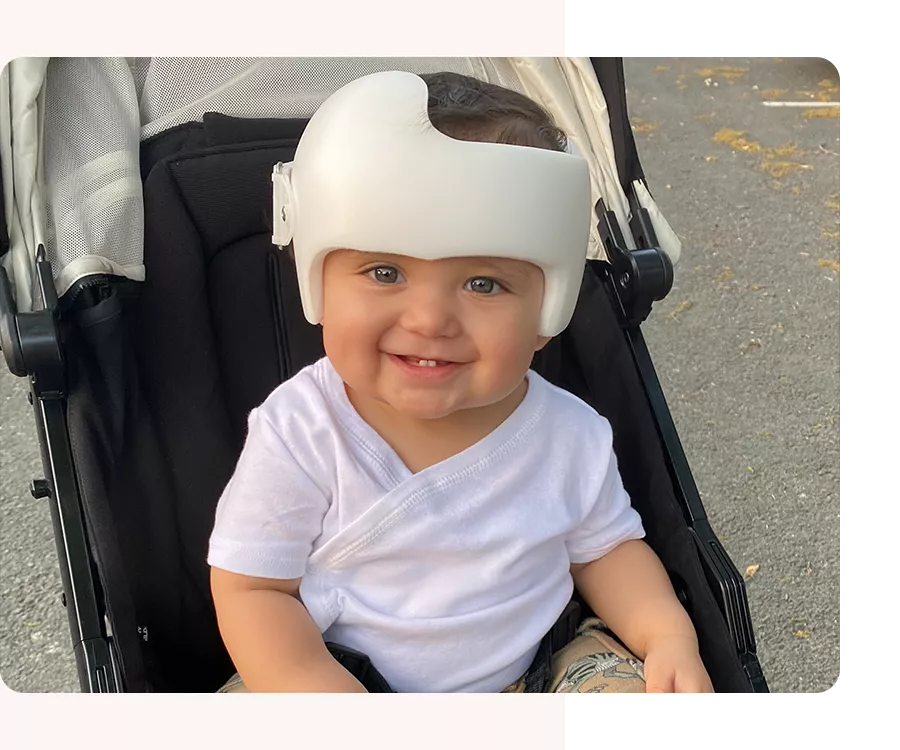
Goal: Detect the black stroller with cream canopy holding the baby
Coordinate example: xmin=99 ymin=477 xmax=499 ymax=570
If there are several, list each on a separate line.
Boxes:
xmin=0 ymin=57 xmax=768 ymax=695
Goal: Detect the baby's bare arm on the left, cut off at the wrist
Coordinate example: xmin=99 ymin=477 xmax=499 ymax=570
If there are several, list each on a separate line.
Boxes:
xmin=210 ymin=567 xmax=366 ymax=693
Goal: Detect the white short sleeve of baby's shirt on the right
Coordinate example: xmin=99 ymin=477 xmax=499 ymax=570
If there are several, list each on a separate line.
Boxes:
xmin=566 ymin=434 xmax=645 ymax=563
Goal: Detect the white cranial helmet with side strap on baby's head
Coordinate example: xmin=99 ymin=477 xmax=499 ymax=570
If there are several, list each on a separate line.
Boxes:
xmin=272 ymin=72 xmax=592 ymax=336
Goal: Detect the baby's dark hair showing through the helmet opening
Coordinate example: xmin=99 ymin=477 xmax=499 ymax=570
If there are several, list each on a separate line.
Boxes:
xmin=421 ymin=73 xmax=567 ymax=151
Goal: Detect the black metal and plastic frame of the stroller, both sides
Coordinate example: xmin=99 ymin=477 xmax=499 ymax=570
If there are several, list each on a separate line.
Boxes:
xmin=0 ymin=57 xmax=768 ymax=695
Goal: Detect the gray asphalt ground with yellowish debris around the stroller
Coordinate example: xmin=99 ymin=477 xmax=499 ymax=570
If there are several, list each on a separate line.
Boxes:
xmin=0 ymin=58 xmax=840 ymax=694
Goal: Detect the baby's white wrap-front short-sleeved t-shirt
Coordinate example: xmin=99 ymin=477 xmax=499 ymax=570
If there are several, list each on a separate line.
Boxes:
xmin=208 ymin=358 xmax=644 ymax=693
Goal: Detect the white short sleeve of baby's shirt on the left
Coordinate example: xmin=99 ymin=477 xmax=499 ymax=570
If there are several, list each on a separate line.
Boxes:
xmin=207 ymin=410 xmax=329 ymax=579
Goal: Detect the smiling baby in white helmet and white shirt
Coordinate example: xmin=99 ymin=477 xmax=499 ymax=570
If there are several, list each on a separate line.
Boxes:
xmin=208 ymin=73 xmax=712 ymax=693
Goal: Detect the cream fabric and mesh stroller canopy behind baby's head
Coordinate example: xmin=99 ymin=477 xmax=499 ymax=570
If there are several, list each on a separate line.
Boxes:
xmin=0 ymin=57 xmax=681 ymax=311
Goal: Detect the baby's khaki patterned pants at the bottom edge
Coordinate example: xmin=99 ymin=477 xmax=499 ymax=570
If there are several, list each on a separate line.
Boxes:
xmin=219 ymin=618 xmax=646 ymax=695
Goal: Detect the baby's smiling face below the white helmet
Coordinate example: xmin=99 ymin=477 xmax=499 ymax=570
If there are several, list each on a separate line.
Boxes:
xmin=322 ymin=250 xmax=547 ymax=419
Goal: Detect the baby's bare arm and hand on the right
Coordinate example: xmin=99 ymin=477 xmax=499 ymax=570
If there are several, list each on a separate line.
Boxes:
xmin=572 ymin=540 xmax=712 ymax=693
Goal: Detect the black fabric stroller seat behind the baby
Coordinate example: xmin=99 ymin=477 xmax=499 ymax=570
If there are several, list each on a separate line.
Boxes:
xmin=56 ymin=115 xmax=764 ymax=694
